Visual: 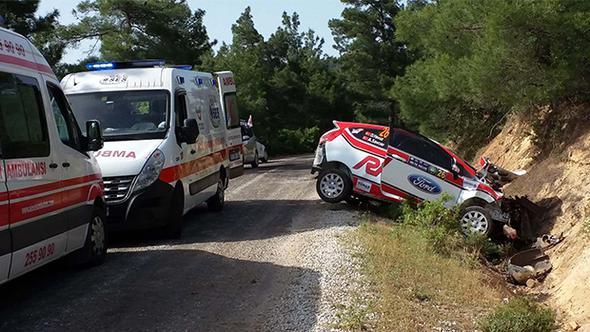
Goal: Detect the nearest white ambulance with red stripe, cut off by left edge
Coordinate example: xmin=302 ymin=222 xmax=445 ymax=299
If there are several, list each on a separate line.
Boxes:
xmin=0 ymin=28 xmax=106 ymax=284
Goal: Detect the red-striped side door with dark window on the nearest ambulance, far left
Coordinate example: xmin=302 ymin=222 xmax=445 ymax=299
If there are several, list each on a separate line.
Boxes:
xmin=0 ymin=73 xmax=67 ymax=279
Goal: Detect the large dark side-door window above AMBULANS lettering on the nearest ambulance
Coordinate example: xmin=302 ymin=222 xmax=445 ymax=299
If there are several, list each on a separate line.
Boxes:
xmin=0 ymin=72 xmax=49 ymax=158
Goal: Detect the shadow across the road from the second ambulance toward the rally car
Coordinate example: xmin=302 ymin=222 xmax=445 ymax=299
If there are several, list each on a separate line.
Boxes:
xmin=111 ymin=198 xmax=353 ymax=247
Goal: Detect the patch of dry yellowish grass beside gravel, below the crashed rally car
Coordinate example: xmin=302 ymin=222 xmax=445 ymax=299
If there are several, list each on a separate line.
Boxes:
xmin=357 ymin=222 xmax=502 ymax=331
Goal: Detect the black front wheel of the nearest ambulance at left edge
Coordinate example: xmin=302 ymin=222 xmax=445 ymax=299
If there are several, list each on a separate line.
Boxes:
xmin=72 ymin=207 xmax=108 ymax=266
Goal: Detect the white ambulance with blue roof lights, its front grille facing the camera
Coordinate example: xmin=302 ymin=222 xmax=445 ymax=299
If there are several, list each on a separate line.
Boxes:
xmin=62 ymin=60 xmax=237 ymax=237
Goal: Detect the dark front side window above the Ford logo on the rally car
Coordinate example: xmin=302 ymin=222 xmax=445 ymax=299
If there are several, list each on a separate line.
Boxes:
xmin=390 ymin=130 xmax=453 ymax=170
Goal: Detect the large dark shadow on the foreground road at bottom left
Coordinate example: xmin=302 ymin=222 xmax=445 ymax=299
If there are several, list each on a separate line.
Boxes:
xmin=0 ymin=249 xmax=320 ymax=331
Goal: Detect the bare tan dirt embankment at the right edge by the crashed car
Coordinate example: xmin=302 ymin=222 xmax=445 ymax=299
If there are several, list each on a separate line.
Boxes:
xmin=478 ymin=105 xmax=590 ymax=330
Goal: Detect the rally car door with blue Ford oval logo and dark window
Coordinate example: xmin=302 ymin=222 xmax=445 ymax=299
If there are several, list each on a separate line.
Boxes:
xmin=381 ymin=129 xmax=461 ymax=204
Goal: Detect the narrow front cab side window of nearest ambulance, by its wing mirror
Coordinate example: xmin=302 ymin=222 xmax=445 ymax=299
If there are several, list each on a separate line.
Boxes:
xmin=47 ymin=83 xmax=81 ymax=150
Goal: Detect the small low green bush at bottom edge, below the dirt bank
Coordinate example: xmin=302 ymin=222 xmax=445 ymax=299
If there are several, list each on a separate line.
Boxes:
xmin=479 ymin=298 xmax=557 ymax=332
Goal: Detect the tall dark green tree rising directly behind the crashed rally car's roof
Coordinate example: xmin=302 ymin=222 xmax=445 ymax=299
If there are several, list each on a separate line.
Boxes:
xmin=329 ymin=0 xmax=412 ymax=123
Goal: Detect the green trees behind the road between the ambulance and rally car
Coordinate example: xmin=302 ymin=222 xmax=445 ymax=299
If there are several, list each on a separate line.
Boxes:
xmin=203 ymin=7 xmax=352 ymax=154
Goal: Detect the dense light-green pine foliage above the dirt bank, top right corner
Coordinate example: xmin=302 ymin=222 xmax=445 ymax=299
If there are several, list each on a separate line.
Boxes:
xmin=398 ymin=0 xmax=590 ymax=156
